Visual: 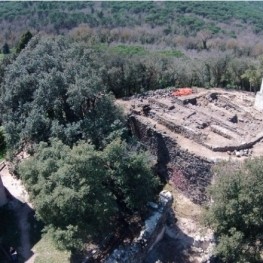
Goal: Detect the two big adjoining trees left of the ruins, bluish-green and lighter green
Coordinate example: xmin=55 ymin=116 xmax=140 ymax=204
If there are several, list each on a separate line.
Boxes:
xmin=1 ymin=36 xmax=159 ymax=251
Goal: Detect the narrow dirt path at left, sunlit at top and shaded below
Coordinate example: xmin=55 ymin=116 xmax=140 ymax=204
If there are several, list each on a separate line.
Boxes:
xmin=0 ymin=163 xmax=35 ymax=263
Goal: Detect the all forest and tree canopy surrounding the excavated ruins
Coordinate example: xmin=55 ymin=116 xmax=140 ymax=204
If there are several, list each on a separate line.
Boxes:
xmin=0 ymin=1 xmax=263 ymax=262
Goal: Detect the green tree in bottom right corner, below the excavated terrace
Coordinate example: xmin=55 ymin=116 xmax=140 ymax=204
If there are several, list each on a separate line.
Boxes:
xmin=206 ymin=158 xmax=263 ymax=262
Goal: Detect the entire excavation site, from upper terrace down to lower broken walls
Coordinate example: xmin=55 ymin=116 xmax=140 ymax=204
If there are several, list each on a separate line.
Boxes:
xmin=106 ymin=88 xmax=263 ymax=263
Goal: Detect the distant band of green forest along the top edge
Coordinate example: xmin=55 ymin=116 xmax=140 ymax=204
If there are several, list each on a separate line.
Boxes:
xmin=0 ymin=1 xmax=263 ymax=45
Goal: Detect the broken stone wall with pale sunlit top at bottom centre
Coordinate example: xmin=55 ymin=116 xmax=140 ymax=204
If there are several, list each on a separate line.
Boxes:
xmin=104 ymin=191 xmax=173 ymax=263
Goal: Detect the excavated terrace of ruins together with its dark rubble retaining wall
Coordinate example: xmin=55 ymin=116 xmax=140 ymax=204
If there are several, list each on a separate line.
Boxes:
xmin=118 ymin=88 xmax=263 ymax=203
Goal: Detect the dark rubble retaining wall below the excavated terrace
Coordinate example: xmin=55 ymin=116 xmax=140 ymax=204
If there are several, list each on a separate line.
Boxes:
xmin=129 ymin=115 xmax=213 ymax=203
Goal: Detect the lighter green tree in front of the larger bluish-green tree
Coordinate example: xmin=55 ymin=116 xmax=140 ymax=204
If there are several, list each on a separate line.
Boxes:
xmin=19 ymin=139 xmax=158 ymax=250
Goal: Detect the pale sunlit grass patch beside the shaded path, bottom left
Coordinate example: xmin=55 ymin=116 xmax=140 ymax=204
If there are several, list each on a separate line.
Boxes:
xmin=33 ymin=234 xmax=71 ymax=263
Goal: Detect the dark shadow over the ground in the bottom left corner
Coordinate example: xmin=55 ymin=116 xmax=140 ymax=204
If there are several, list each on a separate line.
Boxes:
xmin=0 ymin=189 xmax=43 ymax=263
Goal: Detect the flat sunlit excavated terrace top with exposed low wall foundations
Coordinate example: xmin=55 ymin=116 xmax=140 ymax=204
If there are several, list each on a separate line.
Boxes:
xmin=119 ymin=88 xmax=263 ymax=160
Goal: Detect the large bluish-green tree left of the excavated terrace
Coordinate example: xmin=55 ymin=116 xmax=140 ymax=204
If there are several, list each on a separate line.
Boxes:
xmin=2 ymin=38 xmax=123 ymax=153
